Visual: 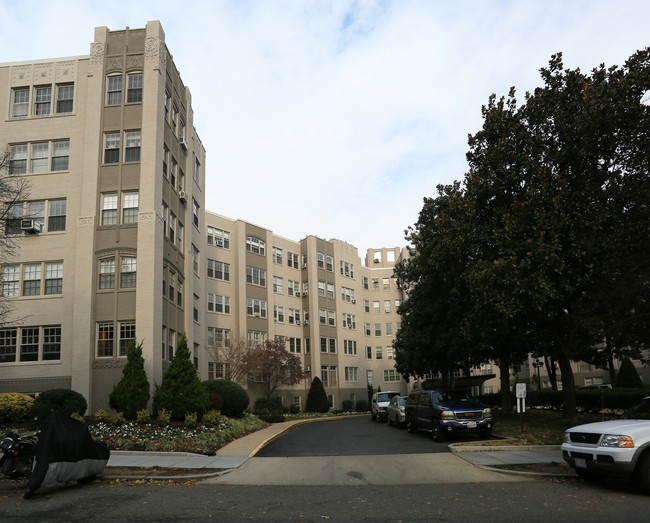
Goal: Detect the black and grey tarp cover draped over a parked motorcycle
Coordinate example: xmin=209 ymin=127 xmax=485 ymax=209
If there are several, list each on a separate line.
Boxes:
xmin=27 ymin=411 xmax=110 ymax=492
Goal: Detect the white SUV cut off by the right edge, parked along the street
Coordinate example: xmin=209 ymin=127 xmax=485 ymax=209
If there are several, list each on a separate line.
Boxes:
xmin=562 ymin=396 xmax=650 ymax=494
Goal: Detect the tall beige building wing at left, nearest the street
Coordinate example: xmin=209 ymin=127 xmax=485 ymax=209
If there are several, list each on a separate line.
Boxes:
xmin=0 ymin=22 xmax=205 ymax=411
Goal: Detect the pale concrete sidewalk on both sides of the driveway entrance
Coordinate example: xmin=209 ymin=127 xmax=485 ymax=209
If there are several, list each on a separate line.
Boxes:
xmin=106 ymin=418 xmax=562 ymax=479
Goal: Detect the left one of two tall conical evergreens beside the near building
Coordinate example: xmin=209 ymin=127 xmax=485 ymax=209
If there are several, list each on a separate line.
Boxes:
xmin=108 ymin=339 xmax=149 ymax=419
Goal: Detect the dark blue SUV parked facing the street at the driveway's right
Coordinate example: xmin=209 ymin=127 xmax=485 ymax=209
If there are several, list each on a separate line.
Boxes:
xmin=406 ymin=387 xmax=494 ymax=441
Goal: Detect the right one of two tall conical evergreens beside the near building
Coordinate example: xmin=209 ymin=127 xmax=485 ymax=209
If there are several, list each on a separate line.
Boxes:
xmin=153 ymin=334 xmax=210 ymax=420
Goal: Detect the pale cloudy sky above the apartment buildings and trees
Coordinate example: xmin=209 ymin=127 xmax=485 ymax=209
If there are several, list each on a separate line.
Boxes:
xmin=0 ymin=0 xmax=650 ymax=258
